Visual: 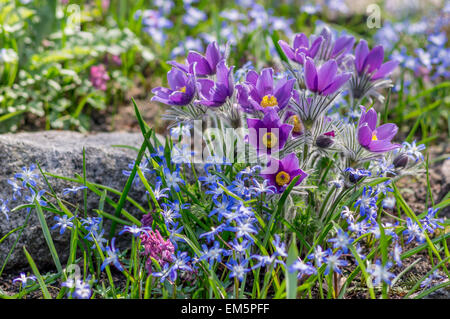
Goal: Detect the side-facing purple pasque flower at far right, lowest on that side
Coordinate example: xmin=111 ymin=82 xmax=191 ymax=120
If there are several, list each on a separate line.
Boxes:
xmin=358 ymin=106 xmax=401 ymax=153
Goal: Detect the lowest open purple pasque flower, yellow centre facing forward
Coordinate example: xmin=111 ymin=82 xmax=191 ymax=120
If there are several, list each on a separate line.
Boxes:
xmin=260 ymin=153 xmax=308 ymax=193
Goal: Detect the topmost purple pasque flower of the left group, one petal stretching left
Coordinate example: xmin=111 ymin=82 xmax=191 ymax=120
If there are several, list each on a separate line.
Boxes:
xmin=168 ymin=41 xmax=224 ymax=76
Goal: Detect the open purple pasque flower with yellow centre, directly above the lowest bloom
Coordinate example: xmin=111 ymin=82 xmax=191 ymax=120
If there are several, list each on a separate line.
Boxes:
xmin=247 ymin=110 xmax=293 ymax=154
